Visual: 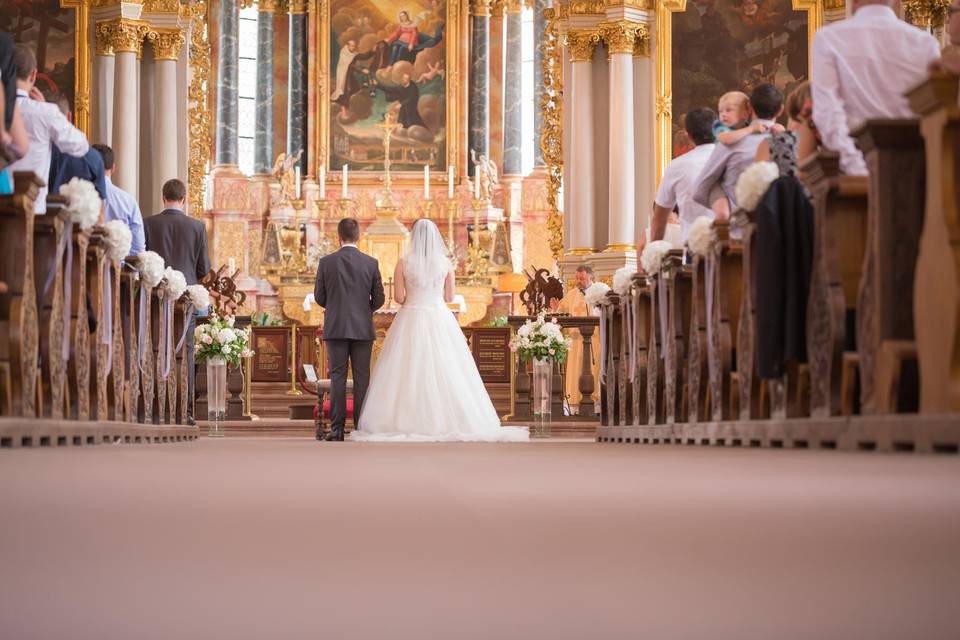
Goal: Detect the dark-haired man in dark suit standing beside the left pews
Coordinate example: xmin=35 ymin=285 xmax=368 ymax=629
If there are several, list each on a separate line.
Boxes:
xmin=143 ymin=178 xmax=210 ymax=426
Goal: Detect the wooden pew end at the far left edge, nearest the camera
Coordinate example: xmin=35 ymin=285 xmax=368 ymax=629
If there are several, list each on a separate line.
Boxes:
xmin=0 ymin=173 xmax=42 ymax=418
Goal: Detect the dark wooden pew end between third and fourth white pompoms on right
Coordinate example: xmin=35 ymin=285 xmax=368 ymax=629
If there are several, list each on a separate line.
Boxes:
xmin=661 ymin=249 xmax=693 ymax=424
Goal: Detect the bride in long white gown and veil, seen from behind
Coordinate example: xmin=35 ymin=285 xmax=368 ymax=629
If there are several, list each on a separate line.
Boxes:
xmin=349 ymin=220 xmax=529 ymax=442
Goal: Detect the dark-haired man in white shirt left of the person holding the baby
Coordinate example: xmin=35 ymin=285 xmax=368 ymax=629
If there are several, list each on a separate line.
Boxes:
xmin=650 ymin=108 xmax=717 ymax=243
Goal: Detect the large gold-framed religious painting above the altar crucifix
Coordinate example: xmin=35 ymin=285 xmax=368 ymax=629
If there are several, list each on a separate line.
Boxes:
xmin=317 ymin=0 xmax=459 ymax=181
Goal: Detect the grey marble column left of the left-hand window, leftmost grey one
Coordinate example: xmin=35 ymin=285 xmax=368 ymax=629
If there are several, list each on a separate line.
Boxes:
xmin=216 ymin=0 xmax=240 ymax=165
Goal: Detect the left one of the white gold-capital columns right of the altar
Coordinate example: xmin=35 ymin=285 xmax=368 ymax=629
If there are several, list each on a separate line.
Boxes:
xmin=565 ymin=29 xmax=600 ymax=255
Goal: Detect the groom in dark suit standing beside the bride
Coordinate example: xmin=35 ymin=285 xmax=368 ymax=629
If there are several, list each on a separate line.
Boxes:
xmin=313 ymin=218 xmax=384 ymax=441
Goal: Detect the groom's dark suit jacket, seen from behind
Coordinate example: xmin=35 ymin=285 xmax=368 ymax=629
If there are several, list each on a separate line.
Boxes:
xmin=313 ymin=246 xmax=384 ymax=340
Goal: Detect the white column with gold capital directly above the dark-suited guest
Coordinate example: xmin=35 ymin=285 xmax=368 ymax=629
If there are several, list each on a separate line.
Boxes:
xmin=148 ymin=29 xmax=185 ymax=191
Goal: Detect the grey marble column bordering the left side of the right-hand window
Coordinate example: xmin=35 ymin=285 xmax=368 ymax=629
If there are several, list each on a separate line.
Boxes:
xmin=503 ymin=8 xmax=523 ymax=176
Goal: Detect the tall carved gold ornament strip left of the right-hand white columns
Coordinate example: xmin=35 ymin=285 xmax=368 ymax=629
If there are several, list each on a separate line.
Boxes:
xmin=540 ymin=9 xmax=564 ymax=260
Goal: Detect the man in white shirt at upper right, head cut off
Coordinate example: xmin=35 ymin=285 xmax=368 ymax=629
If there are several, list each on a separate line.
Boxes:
xmin=810 ymin=0 xmax=940 ymax=175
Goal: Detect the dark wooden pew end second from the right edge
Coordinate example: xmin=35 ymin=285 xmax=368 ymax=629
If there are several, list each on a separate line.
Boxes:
xmin=853 ymin=120 xmax=926 ymax=414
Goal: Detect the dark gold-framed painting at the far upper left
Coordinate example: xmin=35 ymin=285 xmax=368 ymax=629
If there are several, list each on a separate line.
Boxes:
xmin=0 ymin=0 xmax=77 ymax=122
